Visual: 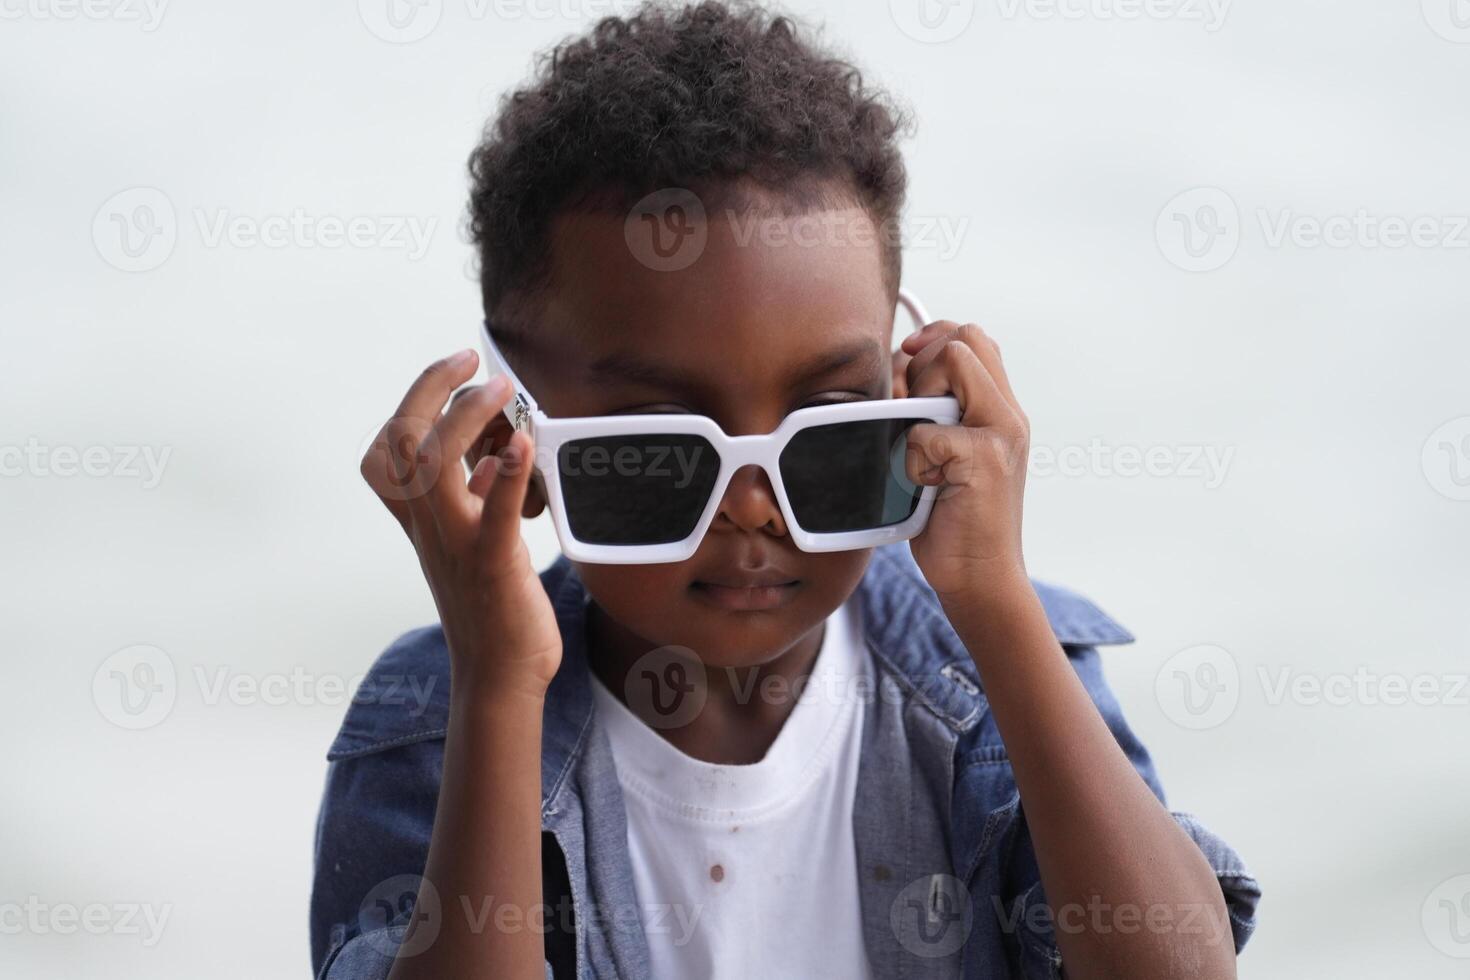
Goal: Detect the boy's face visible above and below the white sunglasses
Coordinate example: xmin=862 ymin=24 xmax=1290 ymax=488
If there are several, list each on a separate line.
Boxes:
xmin=517 ymin=188 xmax=894 ymax=667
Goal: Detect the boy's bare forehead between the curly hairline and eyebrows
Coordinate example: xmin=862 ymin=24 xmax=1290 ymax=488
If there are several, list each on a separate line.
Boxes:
xmin=532 ymin=206 xmax=892 ymax=401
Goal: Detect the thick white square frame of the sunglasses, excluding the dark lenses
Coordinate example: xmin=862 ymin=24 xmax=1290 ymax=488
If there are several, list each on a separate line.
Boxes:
xmin=479 ymin=289 xmax=960 ymax=564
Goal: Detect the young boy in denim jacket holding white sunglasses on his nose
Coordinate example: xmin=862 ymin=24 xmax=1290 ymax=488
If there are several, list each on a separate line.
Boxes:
xmin=312 ymin=3 xmax=1260 ymax=980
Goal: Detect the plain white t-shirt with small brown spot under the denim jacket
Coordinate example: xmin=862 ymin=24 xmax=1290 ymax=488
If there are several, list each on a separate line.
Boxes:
xmin=592 ymin=599 xmax=872 ymax=980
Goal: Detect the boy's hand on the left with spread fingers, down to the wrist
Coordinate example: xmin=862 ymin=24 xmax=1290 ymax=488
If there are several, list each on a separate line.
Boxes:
xmin=362 ymin=350 xmax=562 ymax=699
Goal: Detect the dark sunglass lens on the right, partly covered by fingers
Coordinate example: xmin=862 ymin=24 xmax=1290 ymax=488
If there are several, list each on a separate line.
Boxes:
xmin=781 ymin=419 xmax=925 ymax=533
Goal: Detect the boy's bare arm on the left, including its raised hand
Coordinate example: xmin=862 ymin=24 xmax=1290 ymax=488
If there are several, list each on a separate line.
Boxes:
xmin=362 ymin=351 xmax=562 ymax=980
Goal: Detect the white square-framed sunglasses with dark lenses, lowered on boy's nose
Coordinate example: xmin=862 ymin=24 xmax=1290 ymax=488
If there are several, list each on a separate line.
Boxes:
xmin=481 ymin=289 xmax=960 ymax=564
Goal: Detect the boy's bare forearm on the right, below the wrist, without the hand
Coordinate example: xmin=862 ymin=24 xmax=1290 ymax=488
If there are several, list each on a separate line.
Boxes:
xmin=945 ymin=582 xmax=1235 ymax=980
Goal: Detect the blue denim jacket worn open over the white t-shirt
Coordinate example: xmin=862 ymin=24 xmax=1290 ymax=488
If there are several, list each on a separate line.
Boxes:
xmin=312 ymin=544 xmax=1260 ymax=980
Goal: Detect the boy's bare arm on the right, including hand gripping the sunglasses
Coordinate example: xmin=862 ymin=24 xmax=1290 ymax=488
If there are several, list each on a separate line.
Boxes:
xmin=903 ymin=320 xmax=1235 ymax=980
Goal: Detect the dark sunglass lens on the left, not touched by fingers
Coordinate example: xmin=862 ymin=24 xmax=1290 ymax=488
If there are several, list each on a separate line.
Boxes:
xmin=557 ymin=435 xmax=720 ymax=545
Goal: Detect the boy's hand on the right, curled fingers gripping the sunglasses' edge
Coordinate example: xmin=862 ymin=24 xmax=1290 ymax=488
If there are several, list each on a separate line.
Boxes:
xmin=894 ymin=320 xmax=1030 ymax=602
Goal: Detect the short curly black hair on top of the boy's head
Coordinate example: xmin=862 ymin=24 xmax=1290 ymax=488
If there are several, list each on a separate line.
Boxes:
xmin=469 ymin=0 xmax=906 ymax=317
